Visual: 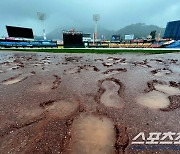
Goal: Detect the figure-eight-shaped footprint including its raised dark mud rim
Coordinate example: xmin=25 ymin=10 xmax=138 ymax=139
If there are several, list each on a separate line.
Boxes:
xmin=96 ymin=78 xmax=124 ymax=108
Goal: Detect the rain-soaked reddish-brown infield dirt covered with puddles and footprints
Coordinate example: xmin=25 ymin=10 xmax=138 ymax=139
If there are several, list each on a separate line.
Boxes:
xmin=0 ymin=51 xmax=180 ymax=154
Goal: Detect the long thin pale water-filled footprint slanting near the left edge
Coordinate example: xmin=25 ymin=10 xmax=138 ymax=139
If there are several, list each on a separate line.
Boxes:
xmin=2 ymin=73 xmax=34 ymax=85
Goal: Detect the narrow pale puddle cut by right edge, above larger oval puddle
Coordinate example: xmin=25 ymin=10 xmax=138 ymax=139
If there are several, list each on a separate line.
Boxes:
xmin=154 ymin=84 xmax=180 ymax=95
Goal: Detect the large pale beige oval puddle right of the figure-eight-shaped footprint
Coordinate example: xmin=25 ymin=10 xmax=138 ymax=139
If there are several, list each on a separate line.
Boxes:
xmin=137 ymin=91 xmax=170 ymax=109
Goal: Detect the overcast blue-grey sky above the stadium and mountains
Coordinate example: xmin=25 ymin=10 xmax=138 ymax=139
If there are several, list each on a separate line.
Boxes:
xmin=0 ymin=0 xmax=180 ymax=36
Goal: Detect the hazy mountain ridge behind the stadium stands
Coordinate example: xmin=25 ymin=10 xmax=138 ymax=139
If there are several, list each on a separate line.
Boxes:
xmin=35 ymin=23 xmax=165 ymax=40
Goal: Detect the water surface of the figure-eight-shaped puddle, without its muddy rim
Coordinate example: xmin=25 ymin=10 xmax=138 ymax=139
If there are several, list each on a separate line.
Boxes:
xmin=100 ymin=81 xmax=124 ymax=108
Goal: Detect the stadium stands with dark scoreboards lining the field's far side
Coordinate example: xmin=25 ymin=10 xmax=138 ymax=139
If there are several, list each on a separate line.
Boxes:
xmin=0 ymin=20 xmax=180 ymax=48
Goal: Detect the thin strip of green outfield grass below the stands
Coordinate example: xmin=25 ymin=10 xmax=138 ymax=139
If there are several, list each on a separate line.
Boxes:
xmin=0 ymin=49 xmax=180 ymax=54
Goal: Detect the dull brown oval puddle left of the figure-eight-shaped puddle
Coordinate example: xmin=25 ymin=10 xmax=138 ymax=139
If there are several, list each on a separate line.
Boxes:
xmin=46 ymin=100 xmax=78 ymax=117
